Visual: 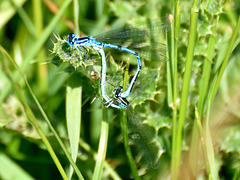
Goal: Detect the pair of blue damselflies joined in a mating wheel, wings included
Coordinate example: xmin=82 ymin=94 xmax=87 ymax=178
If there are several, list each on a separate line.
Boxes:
xmin=52 ymin=17 xmax=168 ymax=169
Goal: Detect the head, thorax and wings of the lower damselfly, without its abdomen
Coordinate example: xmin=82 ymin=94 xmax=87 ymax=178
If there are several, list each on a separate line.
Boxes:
xmin=102 ymin=70 xmax=164 ymax=168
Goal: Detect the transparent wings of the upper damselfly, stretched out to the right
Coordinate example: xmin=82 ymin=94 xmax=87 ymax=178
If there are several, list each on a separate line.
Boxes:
xmin=94 ymin=20 xmax=169 ymax=61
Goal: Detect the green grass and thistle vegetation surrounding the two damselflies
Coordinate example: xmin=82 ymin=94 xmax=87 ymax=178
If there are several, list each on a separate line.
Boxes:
xmin=0 ymin=0 xmax=240 ymax=179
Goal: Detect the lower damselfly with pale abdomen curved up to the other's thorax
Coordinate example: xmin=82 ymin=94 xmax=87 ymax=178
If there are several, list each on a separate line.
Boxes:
xmin=100 ymin=51 xmax=164 ymax=167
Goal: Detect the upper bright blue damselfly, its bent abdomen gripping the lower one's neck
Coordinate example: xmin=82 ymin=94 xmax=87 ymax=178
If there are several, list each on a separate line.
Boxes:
xmin=66 ymin=20 xmax=167 ymax=100
